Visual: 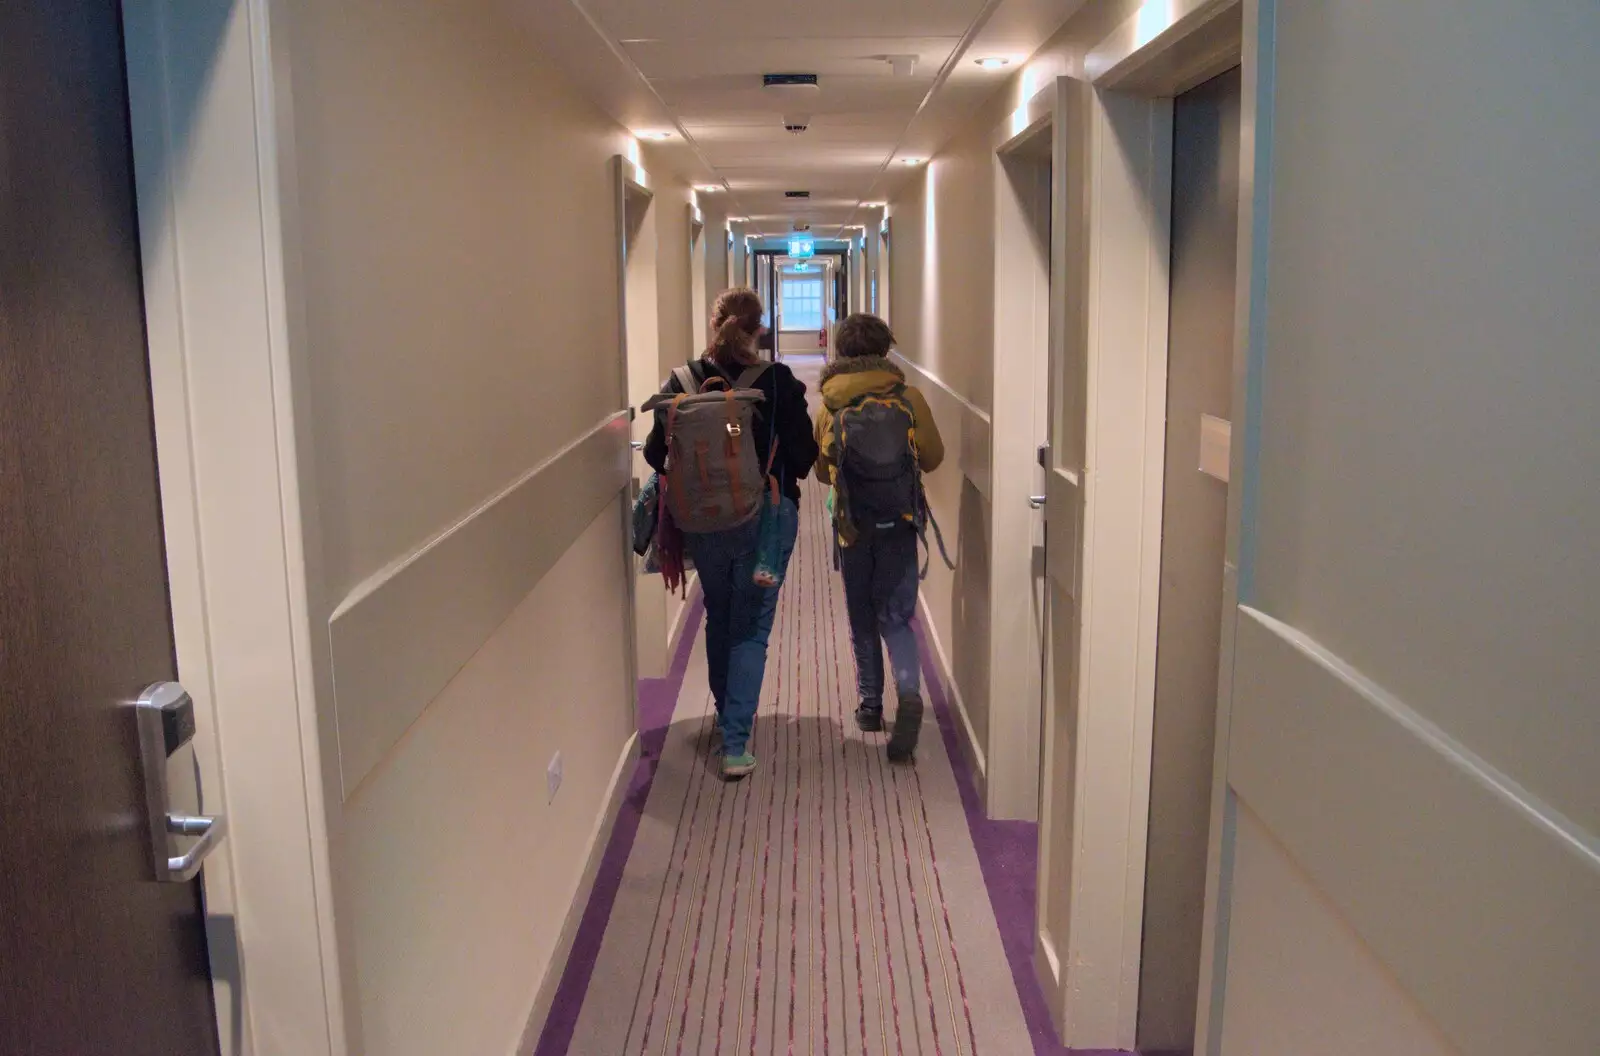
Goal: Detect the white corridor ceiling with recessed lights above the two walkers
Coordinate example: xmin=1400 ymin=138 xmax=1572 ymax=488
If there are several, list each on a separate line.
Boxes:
xmin=506 ymin=0 xmax=1083 ymax=235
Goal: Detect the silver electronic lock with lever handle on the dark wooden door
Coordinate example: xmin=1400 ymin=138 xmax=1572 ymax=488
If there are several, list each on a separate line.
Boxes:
xmin=134 ymin=682 xmax=227 ymax=883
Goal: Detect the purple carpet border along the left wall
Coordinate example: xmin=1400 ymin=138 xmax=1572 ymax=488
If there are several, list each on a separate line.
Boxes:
xmin=533 ymin=592 xmax=706 ymax=1056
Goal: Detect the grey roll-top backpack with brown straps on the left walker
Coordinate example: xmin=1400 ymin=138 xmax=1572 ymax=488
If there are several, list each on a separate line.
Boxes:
xmin=645 ymin=363 xmax=768 ymax=533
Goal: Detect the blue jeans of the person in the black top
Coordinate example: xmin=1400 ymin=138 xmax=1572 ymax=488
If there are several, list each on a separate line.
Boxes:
xmin=683 ymin=499 xmax=800 ymax=755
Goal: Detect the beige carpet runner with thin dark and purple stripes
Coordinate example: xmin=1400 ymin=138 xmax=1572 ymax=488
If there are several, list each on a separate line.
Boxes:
xmin=560 ymin=451 xmax=1034 ymax=1056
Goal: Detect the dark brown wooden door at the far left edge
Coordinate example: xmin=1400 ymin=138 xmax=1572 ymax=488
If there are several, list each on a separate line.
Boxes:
xmin=0 ymin=0 xmax=218 ymax=1056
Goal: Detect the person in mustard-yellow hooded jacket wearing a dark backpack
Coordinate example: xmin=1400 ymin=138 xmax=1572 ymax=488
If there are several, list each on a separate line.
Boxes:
xmin=816 ymin=314 xmax=944 ymax=763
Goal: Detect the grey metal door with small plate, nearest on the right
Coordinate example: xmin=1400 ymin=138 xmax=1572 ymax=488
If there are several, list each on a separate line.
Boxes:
xmin=1139 ymin=69 xmax=1240 ymax=1053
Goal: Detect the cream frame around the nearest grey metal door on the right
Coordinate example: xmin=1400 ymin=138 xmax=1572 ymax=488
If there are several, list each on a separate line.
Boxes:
xmin=1024 ymin=0 xmax=1256 ymax=1050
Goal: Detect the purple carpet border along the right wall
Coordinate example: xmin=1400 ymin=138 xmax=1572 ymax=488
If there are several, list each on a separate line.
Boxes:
xmin=915 ymin=616 xmax=1139 ymax=1056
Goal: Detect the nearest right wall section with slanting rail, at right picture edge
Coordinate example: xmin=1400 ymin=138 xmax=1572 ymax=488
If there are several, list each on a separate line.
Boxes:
xmin=1222 ymin=0 xmax=1600 ymax=1056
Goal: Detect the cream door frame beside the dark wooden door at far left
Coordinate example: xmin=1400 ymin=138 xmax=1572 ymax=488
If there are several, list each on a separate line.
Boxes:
xmin=122 ymin=0 xmax=350 ymax=1056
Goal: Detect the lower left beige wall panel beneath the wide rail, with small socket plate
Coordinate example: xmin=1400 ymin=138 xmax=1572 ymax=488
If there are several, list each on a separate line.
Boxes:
xmin=342 ymin=509 xmax=629 ymax=1056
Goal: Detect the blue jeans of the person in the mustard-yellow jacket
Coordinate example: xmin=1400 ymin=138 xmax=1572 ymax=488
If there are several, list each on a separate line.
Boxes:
xmin=838 ymin=525 xmax=922 ymax=709
